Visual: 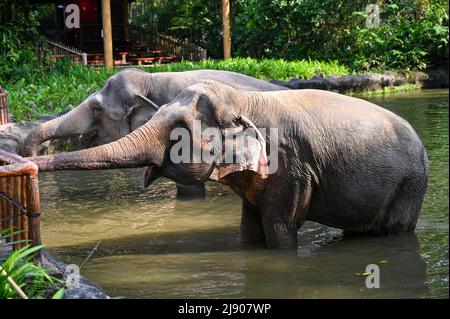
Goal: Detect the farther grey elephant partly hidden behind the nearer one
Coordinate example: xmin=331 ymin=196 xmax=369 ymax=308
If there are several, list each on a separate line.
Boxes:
xmin=21 ymin=69 xmax=287 ymax=198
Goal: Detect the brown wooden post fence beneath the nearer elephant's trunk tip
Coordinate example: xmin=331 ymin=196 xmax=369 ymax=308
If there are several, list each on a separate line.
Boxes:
xmin=0 ymin=150 xmax=41 ymax=254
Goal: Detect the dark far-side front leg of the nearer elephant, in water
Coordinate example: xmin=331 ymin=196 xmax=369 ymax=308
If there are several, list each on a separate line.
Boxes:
xmin=241 ymin=202 xmax=264 ymax=243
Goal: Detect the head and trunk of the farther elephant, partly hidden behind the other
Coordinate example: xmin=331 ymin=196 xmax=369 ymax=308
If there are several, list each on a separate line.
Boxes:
xmin=21 ymin=69 xmax=158 ymax=156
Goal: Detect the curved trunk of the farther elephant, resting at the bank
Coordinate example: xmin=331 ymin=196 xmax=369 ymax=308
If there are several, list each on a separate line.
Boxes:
xmin=21 ymin=103 xmax=94 ymax=156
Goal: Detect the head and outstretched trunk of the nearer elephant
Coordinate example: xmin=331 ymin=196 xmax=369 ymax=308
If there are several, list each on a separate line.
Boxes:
xmin=31 ymin=81 xmax=267 ymax=186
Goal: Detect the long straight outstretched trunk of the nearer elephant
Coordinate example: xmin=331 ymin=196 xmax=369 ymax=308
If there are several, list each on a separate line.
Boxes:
xmin=28 ymin=122 xmax=165 ymax=171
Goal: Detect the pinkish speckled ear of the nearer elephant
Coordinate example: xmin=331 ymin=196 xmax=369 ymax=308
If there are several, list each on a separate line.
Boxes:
xmin=210 ymin=115 xmax=269 ymax=181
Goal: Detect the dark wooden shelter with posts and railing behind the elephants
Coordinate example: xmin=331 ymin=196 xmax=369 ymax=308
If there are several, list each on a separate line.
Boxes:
xmin=0 ymin=0 xmax=206 ymax=68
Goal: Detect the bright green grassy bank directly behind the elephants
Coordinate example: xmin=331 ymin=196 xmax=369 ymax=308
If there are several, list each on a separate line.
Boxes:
xmin=0 ymin=58 xmax=351 ymax=120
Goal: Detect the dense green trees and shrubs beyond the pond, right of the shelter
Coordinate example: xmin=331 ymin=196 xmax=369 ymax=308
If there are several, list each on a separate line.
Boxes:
xmin=136 ymin=0 xmax=448 ymax=71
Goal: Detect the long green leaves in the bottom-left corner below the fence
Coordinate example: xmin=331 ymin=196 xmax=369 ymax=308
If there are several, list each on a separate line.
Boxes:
xmin=0 ymin=229 xmax=62 ymax=299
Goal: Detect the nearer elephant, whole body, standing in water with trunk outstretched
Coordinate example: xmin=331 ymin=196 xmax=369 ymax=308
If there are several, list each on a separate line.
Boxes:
xmin=29 ymin=81 xmax=428 ymax=248
